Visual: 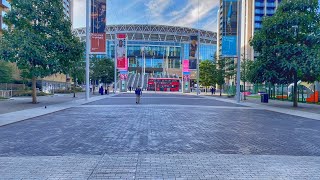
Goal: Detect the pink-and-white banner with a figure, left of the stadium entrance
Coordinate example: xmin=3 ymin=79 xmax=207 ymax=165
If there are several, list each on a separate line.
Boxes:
xmin=116 ymin=34 xmax=128 ymax=71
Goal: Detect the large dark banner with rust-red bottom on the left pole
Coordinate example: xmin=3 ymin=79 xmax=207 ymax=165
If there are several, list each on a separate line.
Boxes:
xmin=90 ymin=0 xmax=107 ymax=54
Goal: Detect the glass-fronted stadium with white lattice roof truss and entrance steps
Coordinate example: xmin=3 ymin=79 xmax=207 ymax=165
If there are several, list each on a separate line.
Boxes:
xmin=74 ymin=24 xmax=217 ymax=90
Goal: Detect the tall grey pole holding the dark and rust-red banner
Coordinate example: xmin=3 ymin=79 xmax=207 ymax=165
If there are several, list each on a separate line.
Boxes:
xmin=86 ymin=0 xmax=93 ymax=100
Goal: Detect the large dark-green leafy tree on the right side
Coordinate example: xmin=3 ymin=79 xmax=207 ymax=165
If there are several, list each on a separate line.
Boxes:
xmin=251 ymin=0 xmax=320 ymax=107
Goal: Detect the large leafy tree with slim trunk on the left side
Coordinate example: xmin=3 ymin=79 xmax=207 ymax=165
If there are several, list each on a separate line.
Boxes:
xmin=0 ymin=0 xmax=75 ymax=103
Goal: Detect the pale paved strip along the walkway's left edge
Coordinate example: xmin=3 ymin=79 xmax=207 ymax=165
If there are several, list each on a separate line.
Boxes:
xmin=0 ymin=94 xmax=116 ymax=127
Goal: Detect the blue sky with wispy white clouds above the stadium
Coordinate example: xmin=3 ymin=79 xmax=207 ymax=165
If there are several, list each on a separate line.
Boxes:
xmin=74 ymin=0 xmax=219 ymax=31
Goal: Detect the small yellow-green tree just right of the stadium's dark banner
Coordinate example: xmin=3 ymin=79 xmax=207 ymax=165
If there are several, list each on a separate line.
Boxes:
xmin=199 ymin=60 xmax=216 ymax=90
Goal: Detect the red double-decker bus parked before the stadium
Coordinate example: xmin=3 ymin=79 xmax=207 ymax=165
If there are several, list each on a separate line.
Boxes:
xmin=147 ymin=78 xmax=180 ymax=92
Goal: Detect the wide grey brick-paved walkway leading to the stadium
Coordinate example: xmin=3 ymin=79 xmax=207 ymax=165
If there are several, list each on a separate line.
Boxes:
xmin=0 ymin=93 xmax=320 ymax=179
